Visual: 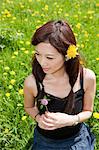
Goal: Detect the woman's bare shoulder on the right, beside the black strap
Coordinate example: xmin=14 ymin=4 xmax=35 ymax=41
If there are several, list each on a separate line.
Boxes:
xmin=84 ymin=68 xmax=96 ymax=90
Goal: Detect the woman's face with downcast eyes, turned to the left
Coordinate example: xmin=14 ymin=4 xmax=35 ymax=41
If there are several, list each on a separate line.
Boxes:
xmin=36 ymin=42 xmax=64 ymax=74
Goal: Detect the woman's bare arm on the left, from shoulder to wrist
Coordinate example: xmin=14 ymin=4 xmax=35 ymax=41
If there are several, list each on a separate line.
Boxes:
xmin=24 ymin=75 xmax=39 ymax=119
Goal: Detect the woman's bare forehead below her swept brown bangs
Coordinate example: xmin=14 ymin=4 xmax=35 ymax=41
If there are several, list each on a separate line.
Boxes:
xmin=35 ymin=42 xmax=59 ymax=55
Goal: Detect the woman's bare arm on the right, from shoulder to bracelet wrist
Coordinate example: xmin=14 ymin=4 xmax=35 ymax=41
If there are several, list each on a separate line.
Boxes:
xmin=74 ymin=69 xmax=96 ymax=122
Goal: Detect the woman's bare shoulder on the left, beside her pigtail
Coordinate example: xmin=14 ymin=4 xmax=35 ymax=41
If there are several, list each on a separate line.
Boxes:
xmin=24 ymin=74 xmax=37 ymax=96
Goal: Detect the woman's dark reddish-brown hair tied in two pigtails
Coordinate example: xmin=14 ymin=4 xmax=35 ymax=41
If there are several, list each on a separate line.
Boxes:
xmin=31 ymin=20 xmax=79 ymax=113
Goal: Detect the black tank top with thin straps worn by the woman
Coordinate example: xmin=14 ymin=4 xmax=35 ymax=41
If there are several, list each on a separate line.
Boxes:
xmin=35 ymin=69 xmax=84 ymax=139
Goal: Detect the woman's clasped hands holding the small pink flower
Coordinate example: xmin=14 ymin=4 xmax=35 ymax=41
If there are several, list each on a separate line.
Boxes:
xmin=37 ymin=112 xmax=76 ymax=130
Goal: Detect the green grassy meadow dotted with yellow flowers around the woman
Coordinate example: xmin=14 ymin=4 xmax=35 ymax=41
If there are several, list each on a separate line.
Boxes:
xmin=0 ymin=0 xmax=99 ymax=150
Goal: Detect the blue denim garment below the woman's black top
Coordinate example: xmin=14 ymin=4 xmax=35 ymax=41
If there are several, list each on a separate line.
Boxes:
xmin=31 ymin=123 xmax=95 ymax=150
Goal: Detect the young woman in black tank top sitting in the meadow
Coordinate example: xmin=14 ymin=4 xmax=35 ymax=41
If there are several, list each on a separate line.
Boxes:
xmin=24 ymin=20 xmax=96 ymax=150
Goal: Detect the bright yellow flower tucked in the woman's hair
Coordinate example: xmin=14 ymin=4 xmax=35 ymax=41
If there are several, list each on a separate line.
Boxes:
xmin=66 ymin=45 xmax=78 ymax=59
